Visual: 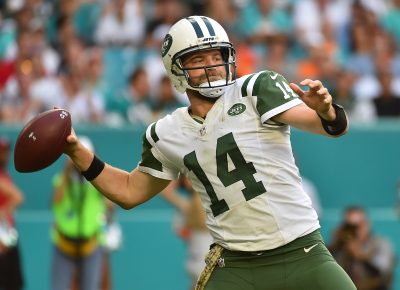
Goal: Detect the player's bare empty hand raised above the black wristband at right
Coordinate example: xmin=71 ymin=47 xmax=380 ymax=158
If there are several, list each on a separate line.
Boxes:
xmin=290 ymin=79 xmax=336 ymax=120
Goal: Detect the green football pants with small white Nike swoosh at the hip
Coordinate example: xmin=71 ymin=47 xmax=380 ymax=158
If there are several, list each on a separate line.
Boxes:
xmin=205 ymin=230 xmax=356 ymax=290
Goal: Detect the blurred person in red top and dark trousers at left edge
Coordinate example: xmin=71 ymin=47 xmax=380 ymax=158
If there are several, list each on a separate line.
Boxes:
xmin=0 ymin=137 xmax=24 ymax=290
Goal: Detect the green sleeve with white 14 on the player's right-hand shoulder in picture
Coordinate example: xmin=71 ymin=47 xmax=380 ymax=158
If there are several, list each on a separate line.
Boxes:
xmin=242 ymin=71 xmax=298 ymax=116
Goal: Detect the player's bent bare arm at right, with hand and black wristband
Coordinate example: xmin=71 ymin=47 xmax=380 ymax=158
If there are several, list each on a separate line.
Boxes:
xmin=273 ymin=79 xmax=348 ymax=137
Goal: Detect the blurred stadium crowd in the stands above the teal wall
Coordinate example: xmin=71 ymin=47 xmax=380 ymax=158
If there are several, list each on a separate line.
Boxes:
xmin=0 ymin=0 xmax=400 ymax=126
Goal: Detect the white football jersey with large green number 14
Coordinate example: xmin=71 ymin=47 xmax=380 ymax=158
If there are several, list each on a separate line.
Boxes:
xmin=139 ymin=71 xmax=320 ymax=251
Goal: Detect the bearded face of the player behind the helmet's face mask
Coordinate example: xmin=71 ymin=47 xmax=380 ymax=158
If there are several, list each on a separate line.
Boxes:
xmin=183 ymin=49 xmax=226 ymax=86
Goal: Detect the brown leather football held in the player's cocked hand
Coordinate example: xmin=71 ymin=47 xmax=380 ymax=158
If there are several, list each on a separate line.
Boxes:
xmin=14 ymin=109 xmax=71 ymax=172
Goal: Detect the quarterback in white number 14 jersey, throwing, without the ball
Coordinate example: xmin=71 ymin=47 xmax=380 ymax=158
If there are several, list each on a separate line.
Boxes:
xmin=65 ymin=16 xmax=356 ymax=290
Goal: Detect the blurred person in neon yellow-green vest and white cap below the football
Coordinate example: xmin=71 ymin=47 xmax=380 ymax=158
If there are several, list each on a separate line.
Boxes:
xmin=51 ymin=136 xmax=111 ymax=290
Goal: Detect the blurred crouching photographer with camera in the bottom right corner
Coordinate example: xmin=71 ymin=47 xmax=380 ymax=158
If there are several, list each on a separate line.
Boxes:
xmin=330 ymin=206 xmax=395 ymax=290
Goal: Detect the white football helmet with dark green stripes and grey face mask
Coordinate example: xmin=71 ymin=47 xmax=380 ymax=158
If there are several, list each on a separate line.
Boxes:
xmin=161 ymin=16 xmax=236 ymax=98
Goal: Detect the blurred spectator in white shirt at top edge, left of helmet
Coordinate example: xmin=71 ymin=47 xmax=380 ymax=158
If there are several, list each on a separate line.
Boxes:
xmin=95 ymin=0 xmax=145 ymax=47
